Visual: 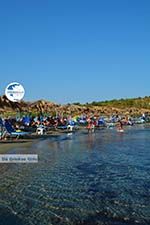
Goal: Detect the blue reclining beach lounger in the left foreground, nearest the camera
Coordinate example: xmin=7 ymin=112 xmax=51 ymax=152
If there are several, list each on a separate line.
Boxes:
xmin=4 ymin=120 xmax=31 ymax=138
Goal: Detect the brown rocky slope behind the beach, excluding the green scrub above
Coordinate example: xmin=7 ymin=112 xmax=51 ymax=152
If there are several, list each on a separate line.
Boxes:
xmin=0 ymin=96 xmax=150 ymax=116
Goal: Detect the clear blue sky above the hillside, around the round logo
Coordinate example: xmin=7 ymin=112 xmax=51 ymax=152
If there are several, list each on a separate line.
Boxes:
xmin=0 ymin=0 xmax=150 ymax=103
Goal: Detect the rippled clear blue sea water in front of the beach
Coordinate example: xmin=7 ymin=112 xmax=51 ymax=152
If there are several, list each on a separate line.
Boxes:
xmin=0 ymin=127 xmax=150 ymax=225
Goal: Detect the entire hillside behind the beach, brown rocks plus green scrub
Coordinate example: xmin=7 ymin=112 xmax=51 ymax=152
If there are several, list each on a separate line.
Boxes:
xmin=0 ymin=96 xmax=150 ymax=116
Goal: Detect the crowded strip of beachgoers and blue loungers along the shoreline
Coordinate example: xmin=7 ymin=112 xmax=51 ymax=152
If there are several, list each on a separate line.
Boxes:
xmin=0 ymin=114 xmax=146 ymax=139
